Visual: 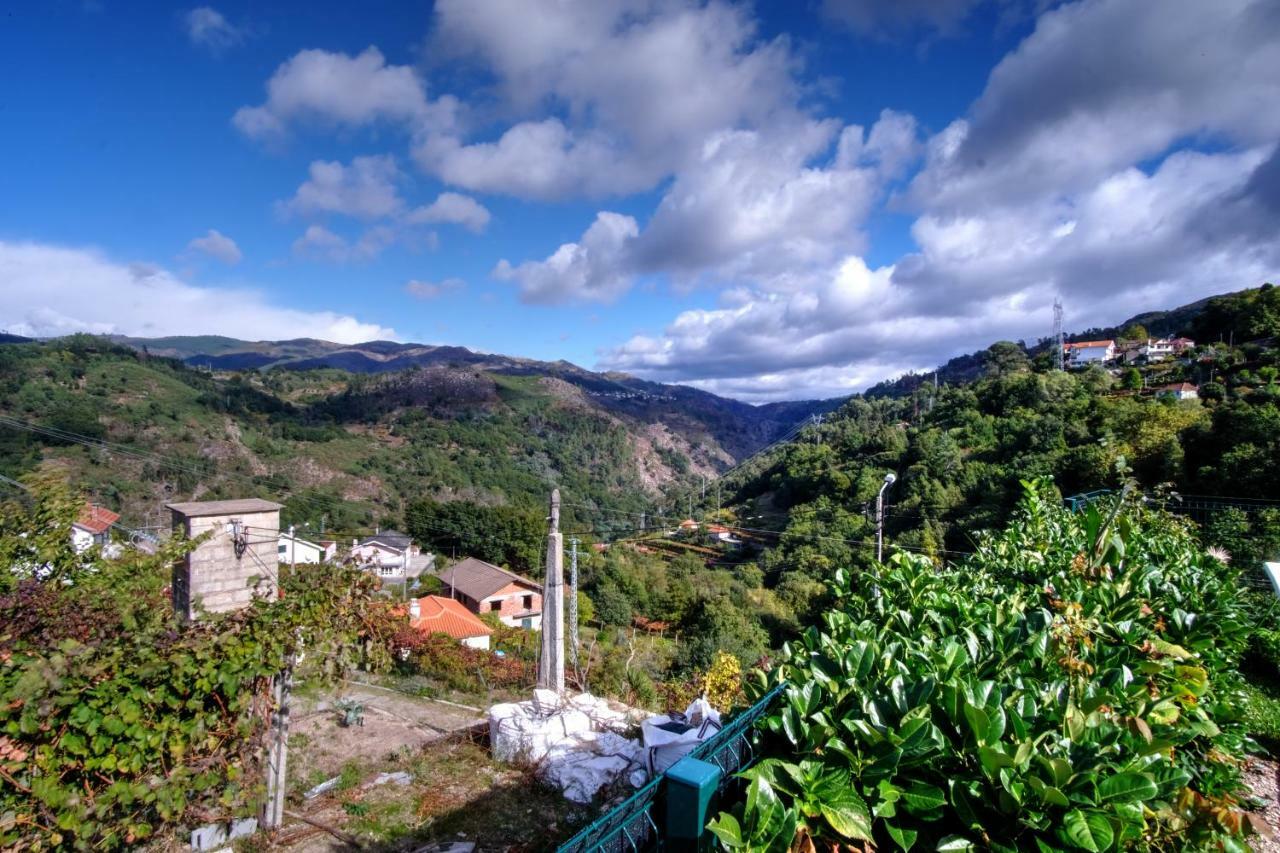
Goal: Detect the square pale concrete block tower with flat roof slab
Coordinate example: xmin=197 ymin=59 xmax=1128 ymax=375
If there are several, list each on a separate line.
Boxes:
xmin=165 ymin=498 xmax=280 ymax=620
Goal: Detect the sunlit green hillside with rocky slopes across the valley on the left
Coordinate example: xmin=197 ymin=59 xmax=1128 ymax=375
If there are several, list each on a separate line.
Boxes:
xmin=0 ymin=336 xmax=788 ymax=533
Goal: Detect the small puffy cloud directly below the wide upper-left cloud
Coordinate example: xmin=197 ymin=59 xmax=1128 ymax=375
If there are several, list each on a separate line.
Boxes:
xmin=280 ymin=155 xmax=404 ymax=219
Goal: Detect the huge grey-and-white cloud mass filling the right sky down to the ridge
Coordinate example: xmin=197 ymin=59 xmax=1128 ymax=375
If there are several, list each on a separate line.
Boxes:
xmin=600 ymin=0 xmax=1280 ymax=400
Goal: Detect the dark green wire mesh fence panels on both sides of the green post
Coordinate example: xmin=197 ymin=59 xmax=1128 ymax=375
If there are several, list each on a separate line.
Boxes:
xmin=557 ymin=683 xmax=786 ymax=853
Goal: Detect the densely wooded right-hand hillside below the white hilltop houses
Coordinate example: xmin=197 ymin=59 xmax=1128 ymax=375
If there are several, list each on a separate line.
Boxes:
xmin=555 ymin=295 xmax=1280 ymax=666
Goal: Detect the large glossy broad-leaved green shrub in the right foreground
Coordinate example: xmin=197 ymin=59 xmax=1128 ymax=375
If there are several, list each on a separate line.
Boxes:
xmin=712 ymin=484 xmax=1248 ymax=850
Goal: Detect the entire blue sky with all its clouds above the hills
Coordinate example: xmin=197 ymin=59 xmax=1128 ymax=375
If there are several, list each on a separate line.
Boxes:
xmin=0 ymin=0 xmax=1280 ymax=401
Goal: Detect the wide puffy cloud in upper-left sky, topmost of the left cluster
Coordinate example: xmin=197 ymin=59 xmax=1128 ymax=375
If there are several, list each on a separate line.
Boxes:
xmin=232 ymin=47 xmax=451 ymax=140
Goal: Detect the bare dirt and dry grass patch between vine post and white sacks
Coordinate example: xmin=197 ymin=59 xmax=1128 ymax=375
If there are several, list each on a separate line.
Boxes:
xmin=272 ymin=684 xmax=590 ymax=853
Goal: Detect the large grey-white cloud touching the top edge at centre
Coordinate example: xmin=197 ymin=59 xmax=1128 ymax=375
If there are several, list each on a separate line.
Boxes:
xmin=415 ymin=0 xmax=799 ymax=199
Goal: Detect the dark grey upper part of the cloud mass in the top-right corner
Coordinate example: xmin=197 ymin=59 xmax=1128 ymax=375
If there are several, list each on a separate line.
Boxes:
xmin=913 ymin=0 xmax=1280 ymax=209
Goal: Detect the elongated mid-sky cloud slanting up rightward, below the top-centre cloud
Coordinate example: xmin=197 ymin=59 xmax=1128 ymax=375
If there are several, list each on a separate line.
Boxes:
xmin=494 ymin=111 xmax=916 ymax=302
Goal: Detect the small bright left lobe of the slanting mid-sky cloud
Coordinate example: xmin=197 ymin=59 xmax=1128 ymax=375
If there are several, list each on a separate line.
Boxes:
xmin=493 ymin=211 xmax=640 ymax=305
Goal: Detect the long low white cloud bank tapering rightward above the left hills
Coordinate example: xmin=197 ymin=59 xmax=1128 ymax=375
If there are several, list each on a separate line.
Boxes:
xmin=0 ymin=242 xmax=397 ymax=343
